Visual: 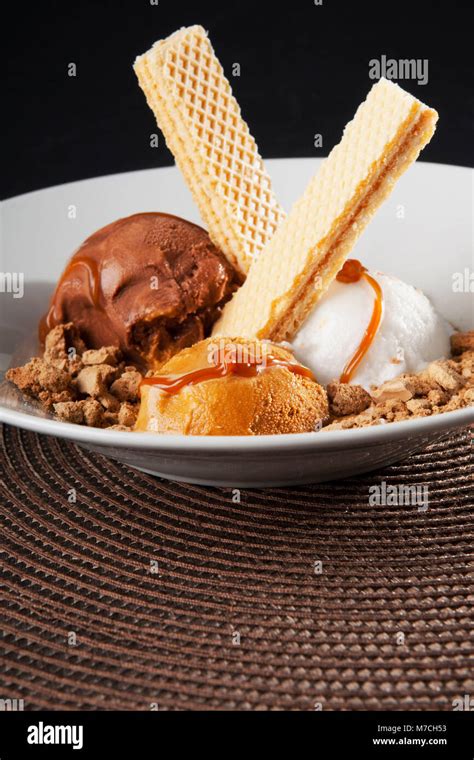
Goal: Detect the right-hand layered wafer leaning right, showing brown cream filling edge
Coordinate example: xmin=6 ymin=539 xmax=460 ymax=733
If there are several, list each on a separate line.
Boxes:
xmin=214 ymin=79 xmax=438 ymax=341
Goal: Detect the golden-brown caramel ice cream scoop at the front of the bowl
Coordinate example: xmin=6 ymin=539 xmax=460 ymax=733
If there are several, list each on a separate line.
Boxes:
xmin=136 ymin=339 xmax=328 ymax=435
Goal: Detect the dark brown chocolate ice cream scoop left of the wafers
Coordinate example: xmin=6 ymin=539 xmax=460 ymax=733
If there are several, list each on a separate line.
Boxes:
xmin=40 ymin=213 xmax=241 ymax=367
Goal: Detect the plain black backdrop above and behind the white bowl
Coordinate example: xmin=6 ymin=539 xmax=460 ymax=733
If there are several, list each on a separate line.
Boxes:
xmin=1 ymin=0 xmax=472 ymax=197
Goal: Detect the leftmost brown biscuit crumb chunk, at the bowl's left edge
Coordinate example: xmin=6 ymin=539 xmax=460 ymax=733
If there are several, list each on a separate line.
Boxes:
xmin=6 ymin=358 xmax=76 ymax=408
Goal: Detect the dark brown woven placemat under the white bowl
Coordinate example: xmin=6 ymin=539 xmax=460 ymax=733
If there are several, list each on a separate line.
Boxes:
xmin=0 ymin=426 xmax=474 ymax=710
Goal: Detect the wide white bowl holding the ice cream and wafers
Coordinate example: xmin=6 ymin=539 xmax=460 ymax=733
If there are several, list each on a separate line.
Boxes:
xmin=0 ymin=159 xmax=474 ymax=488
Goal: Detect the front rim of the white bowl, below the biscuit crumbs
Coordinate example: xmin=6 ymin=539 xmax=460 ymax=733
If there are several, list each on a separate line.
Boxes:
xmin=0 ymin=406 xmax=474 ymax=453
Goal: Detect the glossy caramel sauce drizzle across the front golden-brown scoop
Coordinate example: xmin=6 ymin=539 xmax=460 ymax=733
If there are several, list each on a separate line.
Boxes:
xmin=140 ymin=354 xmax=314 ymax=396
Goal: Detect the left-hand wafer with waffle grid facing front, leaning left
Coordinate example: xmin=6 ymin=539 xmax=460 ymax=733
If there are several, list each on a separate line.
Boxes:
xmin=134 ymin=26 xmax=285 ymax=273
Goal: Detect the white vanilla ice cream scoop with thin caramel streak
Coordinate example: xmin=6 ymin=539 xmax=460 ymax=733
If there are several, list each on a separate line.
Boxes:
xmin=292 ymin=272 xmax=453 ymax=390
